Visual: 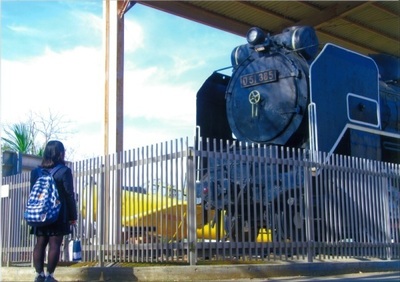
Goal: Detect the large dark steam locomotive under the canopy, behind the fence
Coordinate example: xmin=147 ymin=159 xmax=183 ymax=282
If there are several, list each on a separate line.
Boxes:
xmin=196 ymin=26 xmax=400 ymax=239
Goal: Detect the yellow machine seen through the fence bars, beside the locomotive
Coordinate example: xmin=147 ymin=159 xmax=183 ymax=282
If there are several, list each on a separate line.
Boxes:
xmin=80 ymin=185 xmax=272 ymax=242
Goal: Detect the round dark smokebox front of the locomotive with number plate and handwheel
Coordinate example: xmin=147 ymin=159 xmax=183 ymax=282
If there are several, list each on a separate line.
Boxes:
xmin=226 ymin=52 xmax=308 ymax=145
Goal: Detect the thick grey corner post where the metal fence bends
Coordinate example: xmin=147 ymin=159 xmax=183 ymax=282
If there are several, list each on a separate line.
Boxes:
xmin=186 ymin=147 xmax=197 ymax=265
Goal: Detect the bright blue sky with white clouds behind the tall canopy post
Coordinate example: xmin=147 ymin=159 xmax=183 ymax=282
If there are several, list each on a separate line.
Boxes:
xmin=1 ymin=0 xmax=245 ymax=160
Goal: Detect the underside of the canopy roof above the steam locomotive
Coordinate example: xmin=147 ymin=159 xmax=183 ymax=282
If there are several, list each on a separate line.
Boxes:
xmin=137 ymin=1 xmax=400 ymax=57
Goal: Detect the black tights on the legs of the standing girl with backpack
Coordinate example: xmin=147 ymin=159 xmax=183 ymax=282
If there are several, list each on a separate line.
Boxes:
xmin=33 ymin=235 xmax=63 ymax=273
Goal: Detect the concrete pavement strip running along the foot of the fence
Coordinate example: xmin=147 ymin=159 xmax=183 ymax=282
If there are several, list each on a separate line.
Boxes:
xmin=0 ymin=259 xmax=400 ymax=282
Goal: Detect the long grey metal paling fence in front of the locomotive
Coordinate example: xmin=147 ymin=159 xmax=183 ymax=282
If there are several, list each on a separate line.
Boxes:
xmin=0 ymin=138 xmax=400 ymax=265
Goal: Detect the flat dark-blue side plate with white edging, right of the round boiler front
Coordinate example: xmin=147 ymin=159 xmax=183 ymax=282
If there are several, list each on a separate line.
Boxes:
xmin=309 ymin=44 xmax=381 ymax=157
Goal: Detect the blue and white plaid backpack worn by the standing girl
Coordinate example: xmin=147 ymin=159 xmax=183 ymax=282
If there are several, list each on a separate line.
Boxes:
xmin=24 ymin=165 xmax=62 ymax=226
